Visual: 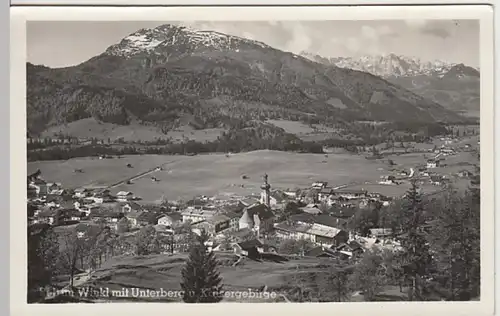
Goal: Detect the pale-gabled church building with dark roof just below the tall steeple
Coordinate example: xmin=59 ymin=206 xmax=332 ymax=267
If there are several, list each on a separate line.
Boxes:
xmin=239 ymin=204 xmax=275 ymax=234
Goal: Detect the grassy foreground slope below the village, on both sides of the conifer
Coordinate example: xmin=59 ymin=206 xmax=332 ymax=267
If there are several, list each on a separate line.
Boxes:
xmin=76 ymin=253 xmax=346 ymax=302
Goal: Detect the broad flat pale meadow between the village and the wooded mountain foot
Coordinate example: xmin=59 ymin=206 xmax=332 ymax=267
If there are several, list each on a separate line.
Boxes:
xmin=28 ymin=150 xmax=387 ymax=201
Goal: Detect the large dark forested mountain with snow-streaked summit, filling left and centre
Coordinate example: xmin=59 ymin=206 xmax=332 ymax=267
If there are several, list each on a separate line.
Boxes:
xmin=27 ymin=24 xmax=464 ymax=139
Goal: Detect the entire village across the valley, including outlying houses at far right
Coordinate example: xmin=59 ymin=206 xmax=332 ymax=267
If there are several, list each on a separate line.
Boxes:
xmin=28 ymin=132 xmax=479 ymax=270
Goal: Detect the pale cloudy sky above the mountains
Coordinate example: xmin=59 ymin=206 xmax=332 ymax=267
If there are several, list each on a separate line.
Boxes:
xmin=26 ymin=20 xmax=479 ymax=68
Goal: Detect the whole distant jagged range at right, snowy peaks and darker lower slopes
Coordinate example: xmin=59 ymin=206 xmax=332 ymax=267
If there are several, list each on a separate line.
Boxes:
xmin=301 ymin=52 xmax=480 ymax=115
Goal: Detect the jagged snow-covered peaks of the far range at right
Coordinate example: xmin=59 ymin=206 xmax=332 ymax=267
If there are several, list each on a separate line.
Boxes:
xmin=301 ymin=53 xmax=474 ymax=78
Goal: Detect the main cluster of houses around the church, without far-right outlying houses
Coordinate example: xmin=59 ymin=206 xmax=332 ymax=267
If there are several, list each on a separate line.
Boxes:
xmin=28 ymin=170 xmax=406 ymax=262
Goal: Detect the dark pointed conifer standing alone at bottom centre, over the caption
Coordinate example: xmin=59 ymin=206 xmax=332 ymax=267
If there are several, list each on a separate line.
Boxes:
xmin=181 ymin=231 xmax=223 ymax=303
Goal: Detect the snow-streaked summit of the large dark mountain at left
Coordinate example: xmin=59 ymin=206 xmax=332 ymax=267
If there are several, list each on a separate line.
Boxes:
xmin=105 ymin=24 xmax=270 ymax=58
